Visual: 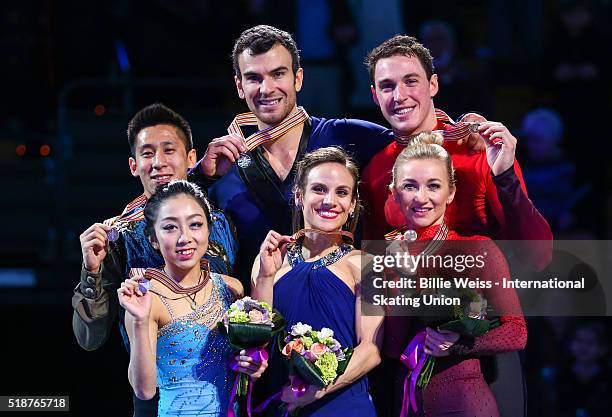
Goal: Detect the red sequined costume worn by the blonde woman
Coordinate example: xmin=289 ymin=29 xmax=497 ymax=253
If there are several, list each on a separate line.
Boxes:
xmin=384 ymin=226 xmax=527 ymax=417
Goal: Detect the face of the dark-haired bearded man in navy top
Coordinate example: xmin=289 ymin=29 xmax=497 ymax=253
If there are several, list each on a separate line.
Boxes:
xmin=234 ymin=44 xmax=302 ymax=128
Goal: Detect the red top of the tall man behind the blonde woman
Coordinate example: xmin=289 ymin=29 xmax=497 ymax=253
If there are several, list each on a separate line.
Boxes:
xmin=360 ymin=116 xmax=552 ymax=270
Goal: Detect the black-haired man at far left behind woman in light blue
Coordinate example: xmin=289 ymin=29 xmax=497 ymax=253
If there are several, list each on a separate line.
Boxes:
xmin=72 ymin=103 xmax=237 ymax=417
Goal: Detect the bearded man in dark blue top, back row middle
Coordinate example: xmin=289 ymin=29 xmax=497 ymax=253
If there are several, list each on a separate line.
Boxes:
xmin=199 ymin=25 xmax=393 ymax=293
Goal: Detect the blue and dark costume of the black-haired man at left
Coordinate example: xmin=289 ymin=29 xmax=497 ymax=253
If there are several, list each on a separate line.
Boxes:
xmin=72 ymin=195 xmax=238 ymax=417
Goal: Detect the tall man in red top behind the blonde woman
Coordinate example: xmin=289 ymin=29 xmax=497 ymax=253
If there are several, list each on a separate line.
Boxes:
xmin=362 ymin=35 xmax=552 ymax=270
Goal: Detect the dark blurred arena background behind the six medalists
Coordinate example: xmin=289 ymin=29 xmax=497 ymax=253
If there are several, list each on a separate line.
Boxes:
xmin=0 ymin=0 xmax=612 ymax=416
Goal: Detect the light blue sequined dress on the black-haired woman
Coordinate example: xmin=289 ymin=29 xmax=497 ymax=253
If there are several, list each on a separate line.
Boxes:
xmin=157 ymin=273 xmax=234 ymax=417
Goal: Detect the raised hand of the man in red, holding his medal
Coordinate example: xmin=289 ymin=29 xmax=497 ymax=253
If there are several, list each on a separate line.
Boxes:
xmin=478 ymin=122 xmax=516 ymax=175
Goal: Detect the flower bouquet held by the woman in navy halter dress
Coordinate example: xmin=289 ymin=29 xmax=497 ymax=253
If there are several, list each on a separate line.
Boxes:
xmin=281 ymin=323 xmax=353 ymax=388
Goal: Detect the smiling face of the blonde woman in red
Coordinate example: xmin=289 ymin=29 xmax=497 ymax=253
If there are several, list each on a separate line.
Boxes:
xmin=392 ymin=159 xmax=455 ymax=229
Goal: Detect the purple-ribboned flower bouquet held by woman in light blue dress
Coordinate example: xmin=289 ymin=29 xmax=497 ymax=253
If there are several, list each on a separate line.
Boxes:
xmin=217 ymin=297 xmax=285 ymax=416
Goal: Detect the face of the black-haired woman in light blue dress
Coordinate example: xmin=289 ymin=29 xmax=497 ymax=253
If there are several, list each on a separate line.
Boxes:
xmin=151 ymin=194 xmax=208 ymax=274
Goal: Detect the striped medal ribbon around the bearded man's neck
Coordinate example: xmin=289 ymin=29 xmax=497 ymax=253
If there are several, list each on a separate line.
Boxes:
xmin=227 ymin=107 xmax=308 ymax=151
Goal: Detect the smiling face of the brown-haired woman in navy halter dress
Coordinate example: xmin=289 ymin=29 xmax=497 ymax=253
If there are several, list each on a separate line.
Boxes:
xmin=295 ymin=162 xmax=357 ymax=232
